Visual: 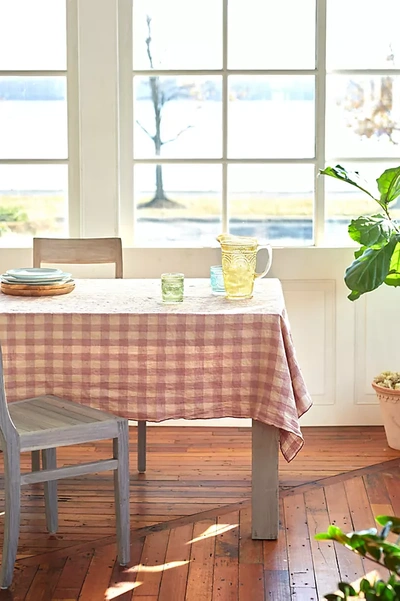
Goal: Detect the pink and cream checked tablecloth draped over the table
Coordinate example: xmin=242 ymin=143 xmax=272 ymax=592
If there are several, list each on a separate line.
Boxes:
xmin=0 ymin=279 xmax=311 ymax=461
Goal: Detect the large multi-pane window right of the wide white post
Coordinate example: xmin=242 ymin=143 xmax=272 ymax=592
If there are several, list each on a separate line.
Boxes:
xmin=132 ymin=0 xmax=400 ymax=246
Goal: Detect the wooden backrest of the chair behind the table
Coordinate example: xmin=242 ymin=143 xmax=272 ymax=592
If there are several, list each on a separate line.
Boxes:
xmin=33 ymin=238 xmax=123 ymax=278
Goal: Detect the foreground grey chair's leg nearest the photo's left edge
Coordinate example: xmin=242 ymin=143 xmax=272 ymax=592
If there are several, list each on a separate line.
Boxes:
xmin=0 ymin=448 xmax=21 ymax=588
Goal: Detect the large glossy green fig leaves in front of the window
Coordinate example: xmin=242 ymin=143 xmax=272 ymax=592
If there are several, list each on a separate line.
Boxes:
xmin=320 ymin=165 xmax=400 ymax=301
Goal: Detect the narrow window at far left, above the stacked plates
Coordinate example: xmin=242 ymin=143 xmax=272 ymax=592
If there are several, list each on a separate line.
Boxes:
xmin=0 ymin=0 xmax=68 ymax=246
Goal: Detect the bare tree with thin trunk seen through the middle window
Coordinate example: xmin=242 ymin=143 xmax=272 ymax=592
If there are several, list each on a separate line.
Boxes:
xmin=136 ymin=15 xmax=195 ymax=208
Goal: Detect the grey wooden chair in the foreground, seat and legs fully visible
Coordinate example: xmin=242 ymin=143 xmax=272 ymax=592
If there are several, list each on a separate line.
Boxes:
xmin=0 ymin=349 xmax=130 ymax=588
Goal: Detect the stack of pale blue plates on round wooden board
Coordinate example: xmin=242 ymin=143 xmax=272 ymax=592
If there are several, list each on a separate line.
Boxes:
xmin=1 ymin=267 xmax=75 ymax=296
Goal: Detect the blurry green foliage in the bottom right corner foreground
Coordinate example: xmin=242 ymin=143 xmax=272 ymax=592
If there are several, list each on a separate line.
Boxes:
xmin=315 ymin=515 xmax=400 ymax=601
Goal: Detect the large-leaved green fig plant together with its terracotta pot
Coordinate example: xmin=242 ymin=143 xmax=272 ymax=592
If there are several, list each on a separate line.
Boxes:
xmin=320 ymin=165 xmax=400 ymax=449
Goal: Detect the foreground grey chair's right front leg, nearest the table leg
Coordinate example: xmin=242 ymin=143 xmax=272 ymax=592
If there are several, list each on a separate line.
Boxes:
xmin=113 ymin=422 xmax=130 ymax=566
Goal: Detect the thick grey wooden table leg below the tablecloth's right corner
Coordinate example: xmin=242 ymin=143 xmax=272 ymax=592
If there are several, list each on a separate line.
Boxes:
xmin=251 ymin=419 xmax=279 ymax=540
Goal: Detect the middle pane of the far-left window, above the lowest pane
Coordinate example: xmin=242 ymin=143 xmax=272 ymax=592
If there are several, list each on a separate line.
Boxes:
xmin=0 ymin=77 xmax=68 ymax=159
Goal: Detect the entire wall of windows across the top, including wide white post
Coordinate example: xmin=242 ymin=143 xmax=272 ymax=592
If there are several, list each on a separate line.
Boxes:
xmin=0 ymin=0 xmax=400 ymax=247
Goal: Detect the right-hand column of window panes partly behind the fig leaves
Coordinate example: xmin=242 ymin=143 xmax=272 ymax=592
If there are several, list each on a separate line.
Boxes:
xmin=325 ymin=0 xmax=400 ymax=245
